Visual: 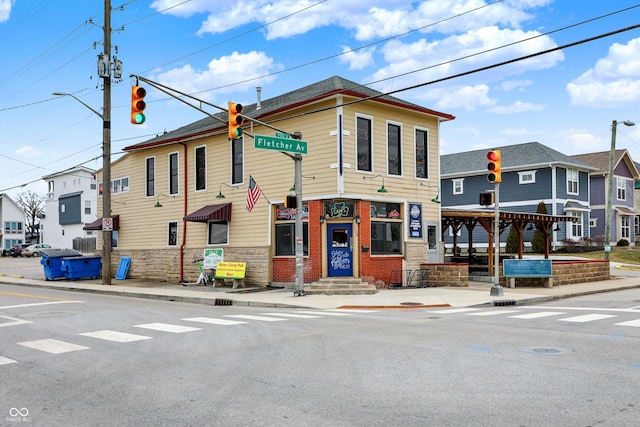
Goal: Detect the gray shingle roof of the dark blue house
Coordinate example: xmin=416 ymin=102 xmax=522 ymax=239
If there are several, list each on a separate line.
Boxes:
xmin=440 ymin=142 xmax=596 ymax=177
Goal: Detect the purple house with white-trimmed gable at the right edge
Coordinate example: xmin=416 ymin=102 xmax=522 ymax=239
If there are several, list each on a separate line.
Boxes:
xmin=572 ymin=149 xmax=640 ymax=246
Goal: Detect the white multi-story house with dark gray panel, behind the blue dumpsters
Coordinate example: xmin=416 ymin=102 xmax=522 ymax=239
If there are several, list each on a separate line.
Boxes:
xmin=40 ymin=166 xmax=98 ymax=251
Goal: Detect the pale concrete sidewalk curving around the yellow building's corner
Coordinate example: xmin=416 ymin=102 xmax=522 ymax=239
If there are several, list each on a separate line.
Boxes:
xmin=0 ymin=275 xmax=640 ymax=309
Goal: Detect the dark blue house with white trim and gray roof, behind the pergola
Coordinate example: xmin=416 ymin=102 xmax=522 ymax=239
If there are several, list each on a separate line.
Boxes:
xmin=440 ymin=142 xmax=597 ymax=251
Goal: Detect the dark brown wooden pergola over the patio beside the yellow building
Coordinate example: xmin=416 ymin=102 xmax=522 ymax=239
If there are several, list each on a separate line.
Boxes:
xmin=441 ymin=208 xmax=577 ymax=271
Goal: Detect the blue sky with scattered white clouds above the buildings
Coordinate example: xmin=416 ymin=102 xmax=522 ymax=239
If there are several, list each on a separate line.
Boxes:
xmin=0 ymin=0 xmax=640 ymax=199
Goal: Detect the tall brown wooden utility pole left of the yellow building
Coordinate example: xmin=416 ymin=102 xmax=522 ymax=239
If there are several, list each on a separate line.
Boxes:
xmin=102 ymin=0 xmax=113 ymax=285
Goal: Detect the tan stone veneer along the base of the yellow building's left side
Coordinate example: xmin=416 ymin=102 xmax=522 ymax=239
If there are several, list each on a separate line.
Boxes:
xmin=111 ymin=246 xmax=269 ymax=287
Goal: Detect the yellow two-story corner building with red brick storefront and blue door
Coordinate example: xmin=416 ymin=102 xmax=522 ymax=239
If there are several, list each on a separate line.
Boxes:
xmin=98 ymin=76 xmax=454 ymax=286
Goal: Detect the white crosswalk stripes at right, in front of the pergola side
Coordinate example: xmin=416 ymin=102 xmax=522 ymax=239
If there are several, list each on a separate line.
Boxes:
xmin=429 ymin=307 xmax=640 ymax=328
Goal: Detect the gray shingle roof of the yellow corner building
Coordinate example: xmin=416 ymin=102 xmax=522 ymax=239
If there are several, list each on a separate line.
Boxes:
xmin=124 ymin=76 xmax=455 ymax=151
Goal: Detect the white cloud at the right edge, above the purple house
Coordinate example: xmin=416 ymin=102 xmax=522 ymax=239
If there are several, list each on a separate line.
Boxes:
xmin=566 ymin=38 xmax=640 ymax=107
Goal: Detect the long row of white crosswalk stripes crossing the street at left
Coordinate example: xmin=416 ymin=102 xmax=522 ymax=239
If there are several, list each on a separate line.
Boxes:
xmin=0 ymin=310 xmax=376 ymax=366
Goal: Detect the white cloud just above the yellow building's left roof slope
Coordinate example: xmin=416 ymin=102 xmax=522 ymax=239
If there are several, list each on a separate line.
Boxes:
xmin=155 ymin=51 xmax=282 ymax=99
